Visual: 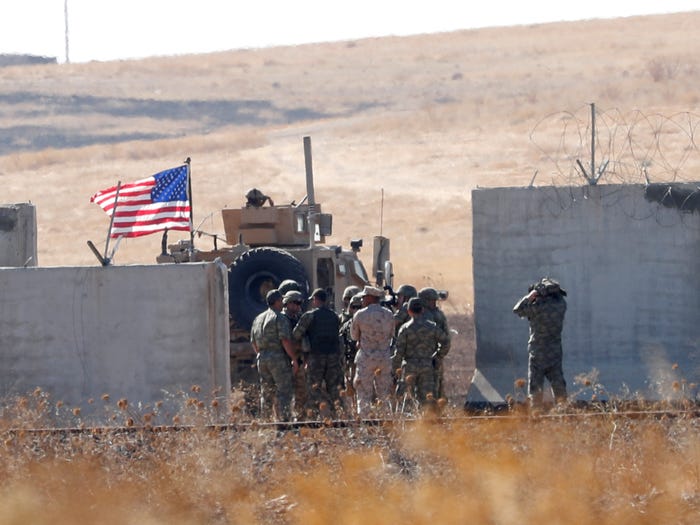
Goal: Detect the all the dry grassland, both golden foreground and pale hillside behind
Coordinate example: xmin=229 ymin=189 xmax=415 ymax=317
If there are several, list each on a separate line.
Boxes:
xmin=0 ymin=12 xmax=700 ymax=524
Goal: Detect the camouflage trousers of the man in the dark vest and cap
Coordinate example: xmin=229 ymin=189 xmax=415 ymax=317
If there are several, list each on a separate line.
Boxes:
xmin=306 ymin=352 xmax=344 ymax=417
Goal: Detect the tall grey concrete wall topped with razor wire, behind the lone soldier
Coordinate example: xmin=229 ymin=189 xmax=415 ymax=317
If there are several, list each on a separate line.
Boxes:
xmin=467 ymin=184 xmax=700 ymax=402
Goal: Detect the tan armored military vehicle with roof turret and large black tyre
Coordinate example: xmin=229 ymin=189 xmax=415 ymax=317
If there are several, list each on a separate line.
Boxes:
xmin=157 ymin=137 xmax=393 ymax=404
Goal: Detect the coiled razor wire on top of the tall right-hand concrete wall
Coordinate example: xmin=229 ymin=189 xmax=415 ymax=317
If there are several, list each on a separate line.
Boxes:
xmin=530 ymin=104 xmax=700 ymax=229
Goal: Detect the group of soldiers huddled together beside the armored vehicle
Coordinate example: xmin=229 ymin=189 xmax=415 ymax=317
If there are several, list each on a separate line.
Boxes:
xmin=250 ymin=280 xmax=450 ymax=421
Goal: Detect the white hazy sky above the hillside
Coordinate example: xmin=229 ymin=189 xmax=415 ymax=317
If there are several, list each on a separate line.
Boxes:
xmin=0 ymin=0 xmax=700 ymax=62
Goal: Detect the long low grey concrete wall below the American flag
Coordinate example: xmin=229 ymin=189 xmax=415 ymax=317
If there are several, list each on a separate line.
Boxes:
xmin=0 ymin=263 xmax=230 ymax=422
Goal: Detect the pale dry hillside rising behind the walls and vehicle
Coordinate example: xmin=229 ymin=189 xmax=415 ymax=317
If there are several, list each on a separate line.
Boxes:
xmin=0 ymin=12 xmax=700 ymax=311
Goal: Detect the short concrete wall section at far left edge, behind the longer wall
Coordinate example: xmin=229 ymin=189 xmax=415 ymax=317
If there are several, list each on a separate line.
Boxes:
xmin=0 ymin=203 xmax=38 ymax=266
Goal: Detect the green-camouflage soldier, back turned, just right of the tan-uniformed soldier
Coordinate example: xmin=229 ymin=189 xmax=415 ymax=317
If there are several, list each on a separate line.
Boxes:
xmin=392 ymin=297 xmax=449 ymax=412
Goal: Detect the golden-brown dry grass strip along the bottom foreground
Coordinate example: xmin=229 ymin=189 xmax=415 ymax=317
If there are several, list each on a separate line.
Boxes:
xmin=0 ymin=406 xmax=700 ymax=525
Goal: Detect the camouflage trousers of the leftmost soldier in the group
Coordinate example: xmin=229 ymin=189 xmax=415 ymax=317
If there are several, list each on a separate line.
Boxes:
xmin=257 ymin=350 xmax=293 ymax=421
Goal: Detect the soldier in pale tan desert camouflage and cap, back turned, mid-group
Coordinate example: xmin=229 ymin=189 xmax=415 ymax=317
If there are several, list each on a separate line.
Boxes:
xmin=351 ymin=286 xmax=394 ymax=416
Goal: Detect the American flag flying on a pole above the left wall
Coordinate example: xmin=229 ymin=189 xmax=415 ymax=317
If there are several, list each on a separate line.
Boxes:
xmin=90 ymin=164 xmax=191 ymax=238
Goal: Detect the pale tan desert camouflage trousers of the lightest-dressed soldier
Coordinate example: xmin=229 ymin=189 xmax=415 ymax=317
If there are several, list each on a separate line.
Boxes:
xmin=353 ymin=348 xmax=394 ymax=417
